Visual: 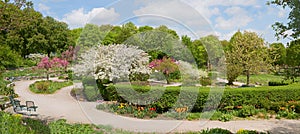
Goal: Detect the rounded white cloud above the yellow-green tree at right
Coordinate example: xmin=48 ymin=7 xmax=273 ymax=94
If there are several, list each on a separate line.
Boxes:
xmin=215 ymin=7 xmax=253 ymax=30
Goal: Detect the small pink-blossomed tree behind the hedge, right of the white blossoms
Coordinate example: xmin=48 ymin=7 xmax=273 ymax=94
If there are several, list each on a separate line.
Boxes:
xmin=149 ymin=57 xmax=179 ymax=84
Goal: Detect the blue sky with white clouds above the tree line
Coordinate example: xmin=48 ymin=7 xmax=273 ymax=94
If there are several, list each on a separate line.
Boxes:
xmin=33 ymin=0 xmax=289 ymax=43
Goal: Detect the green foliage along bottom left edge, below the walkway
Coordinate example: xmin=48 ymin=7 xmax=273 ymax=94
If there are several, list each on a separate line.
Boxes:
xmin=0 ymin=112 xmax=137 ymax=134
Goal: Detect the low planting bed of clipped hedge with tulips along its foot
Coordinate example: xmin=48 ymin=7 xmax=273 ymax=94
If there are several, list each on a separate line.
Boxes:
xmin=98 ymin=84 xmax=300 ymax=121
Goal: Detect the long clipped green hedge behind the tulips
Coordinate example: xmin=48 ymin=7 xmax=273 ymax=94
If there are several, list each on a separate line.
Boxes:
xmin=100 ymin=84 xmax=300 ymax=113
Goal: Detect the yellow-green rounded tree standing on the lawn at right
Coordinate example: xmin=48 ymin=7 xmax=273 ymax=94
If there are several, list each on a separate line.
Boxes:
xmin=226 ymin=31 xmax=269 ymax=85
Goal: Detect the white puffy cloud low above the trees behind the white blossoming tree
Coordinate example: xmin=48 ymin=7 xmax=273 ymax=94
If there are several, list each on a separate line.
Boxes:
xmin=62 ymin=8 xmax=120 ymax=28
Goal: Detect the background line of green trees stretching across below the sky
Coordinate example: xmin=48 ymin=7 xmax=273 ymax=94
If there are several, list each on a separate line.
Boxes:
xmin=0 ymin=0 xmax=300 ymax=83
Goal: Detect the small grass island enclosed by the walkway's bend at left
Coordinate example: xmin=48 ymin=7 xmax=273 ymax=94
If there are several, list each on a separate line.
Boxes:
xmin=29 ymin=81 xmax=73 ymax=94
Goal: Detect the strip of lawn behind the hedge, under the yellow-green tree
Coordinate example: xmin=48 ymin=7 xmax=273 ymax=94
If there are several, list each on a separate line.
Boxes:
xmin=237 ymin=74 xmax=300 ymax=86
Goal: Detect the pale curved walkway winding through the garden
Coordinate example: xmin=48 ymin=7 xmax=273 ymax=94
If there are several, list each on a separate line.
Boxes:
xmin=15 ymin=79 xmax=300 ymax=134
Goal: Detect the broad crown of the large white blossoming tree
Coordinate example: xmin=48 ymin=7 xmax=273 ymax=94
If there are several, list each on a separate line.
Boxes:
xmin=73 ymin=44 xmax=151 ymax=81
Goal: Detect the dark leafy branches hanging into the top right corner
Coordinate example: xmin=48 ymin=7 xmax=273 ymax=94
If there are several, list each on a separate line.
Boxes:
xmin=268 ymin=0 xmax=300 ymax=39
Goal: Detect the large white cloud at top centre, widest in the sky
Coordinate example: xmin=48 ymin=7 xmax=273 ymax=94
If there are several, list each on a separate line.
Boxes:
xmin=133 ymin=0 xmax=212 ymax=31
